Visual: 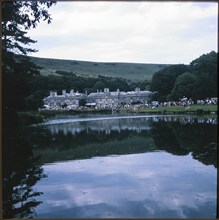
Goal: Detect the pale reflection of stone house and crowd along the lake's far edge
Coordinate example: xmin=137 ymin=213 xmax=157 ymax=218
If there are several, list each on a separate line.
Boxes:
xmin=43 ymin=116 xmax=217 ymax=135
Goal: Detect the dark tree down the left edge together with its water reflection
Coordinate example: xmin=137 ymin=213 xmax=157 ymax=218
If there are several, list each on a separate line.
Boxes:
xmin=1 ymin=1 xmax=55 ymax=218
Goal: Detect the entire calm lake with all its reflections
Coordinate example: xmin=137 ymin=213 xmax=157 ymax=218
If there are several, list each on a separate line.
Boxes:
xmin=3 ymin=114 xmax=217 ymax=218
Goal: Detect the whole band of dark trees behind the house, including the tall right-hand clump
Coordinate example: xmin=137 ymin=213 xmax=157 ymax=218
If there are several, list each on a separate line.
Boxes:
xmin=3 ymin=51 xmax=217 ymax=111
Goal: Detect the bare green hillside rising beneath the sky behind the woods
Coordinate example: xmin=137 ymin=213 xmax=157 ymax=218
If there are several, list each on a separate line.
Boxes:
xmin=30 ymin=57 xmax=169 ymax=81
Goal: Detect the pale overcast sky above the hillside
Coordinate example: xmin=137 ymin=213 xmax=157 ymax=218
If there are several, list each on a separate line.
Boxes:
xmin=28 ymin=1 xmax=218 ymax=64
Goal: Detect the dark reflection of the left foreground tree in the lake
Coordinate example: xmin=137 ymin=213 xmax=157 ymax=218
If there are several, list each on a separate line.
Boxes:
xmin=3 ymin=125 xmax=46 ymax=218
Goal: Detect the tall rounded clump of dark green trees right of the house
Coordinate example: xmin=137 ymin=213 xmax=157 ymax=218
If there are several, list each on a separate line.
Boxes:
xmin=150 ymin=51 xmax=218 ymax=102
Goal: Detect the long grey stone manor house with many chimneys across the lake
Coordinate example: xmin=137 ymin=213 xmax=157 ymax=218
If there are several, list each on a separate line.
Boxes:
xmin=43 ymin=88 xmax=152 ymax=109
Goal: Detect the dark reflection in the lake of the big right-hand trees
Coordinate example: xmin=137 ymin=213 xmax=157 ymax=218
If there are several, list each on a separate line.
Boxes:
xmin=151 ymin=119 xmax=217 ymax=167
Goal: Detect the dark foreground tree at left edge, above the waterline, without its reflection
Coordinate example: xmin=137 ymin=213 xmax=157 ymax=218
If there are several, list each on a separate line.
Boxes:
xmin=2 ymin=1 xmax=54 ymax=115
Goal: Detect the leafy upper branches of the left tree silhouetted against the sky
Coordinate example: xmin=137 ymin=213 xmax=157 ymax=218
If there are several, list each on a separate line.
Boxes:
xmin=2 ymin=1 xmax=55 ymax=56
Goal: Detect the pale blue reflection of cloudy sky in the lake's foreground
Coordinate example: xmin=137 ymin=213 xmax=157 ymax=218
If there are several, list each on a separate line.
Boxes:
xmin=36 ymin=151 xmax=217 ymax=218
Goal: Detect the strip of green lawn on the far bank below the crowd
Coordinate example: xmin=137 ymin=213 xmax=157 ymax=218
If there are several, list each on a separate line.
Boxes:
xmin=135 ymin=105 xmax=217 ymax=114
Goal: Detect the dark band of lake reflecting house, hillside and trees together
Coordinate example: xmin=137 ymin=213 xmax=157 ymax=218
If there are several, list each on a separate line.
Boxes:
xmin=32 ymin=116 xmax=217 ymax=167
